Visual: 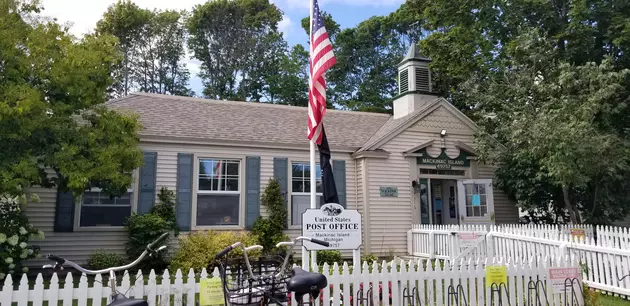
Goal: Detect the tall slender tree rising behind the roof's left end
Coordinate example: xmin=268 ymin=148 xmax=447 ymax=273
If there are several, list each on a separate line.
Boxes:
xmin=96 ymin=0 xmax=152 ymax=97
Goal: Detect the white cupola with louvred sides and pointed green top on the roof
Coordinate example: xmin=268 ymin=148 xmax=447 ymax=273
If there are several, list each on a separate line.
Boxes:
xmin=394 ymin=43 xmax=437 ymax=119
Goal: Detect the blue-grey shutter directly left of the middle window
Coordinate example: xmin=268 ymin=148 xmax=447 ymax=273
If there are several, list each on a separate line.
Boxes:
xmin=175 ymin=153 xmax=193 ymax=231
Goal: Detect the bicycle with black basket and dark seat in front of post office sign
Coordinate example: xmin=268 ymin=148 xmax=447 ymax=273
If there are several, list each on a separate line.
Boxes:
xmin=215 ymin=236 xmax=330 ymax=306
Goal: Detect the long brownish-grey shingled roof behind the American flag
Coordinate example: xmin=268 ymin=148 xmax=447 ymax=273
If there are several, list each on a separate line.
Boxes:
xmin=107 ymin=93 xmax=391 ymax=150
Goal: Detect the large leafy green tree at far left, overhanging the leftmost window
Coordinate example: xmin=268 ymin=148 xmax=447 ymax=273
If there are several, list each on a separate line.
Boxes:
xmin=0 ymin=0 xmax=142 ymax=196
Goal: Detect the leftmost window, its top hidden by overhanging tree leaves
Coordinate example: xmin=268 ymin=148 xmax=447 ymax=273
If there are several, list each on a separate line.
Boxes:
xmin=79 ymin=188 xmax=134 ymax=227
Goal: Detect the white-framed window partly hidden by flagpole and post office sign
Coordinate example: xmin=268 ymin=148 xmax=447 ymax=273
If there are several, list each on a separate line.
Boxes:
xmin=291 ymin=162 xmax=324 ymax=225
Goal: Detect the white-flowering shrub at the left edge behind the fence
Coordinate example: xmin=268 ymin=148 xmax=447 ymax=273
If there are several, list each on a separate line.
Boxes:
xmin=0 ymin=195 xmax=44 ymax=280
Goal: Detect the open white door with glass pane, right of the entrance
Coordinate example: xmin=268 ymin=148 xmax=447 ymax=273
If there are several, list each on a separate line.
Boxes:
xmin=457 ymin=179 xmax=494 ymax=224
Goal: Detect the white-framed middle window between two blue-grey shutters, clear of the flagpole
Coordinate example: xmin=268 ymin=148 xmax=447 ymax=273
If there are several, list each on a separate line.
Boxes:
xmin=196 ymin=158 xmax=241 ymax=226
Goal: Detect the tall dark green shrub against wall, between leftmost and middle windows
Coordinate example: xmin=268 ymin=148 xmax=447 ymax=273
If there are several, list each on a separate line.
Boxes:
xmin=125 ymin=187 xmax=179 ymax=269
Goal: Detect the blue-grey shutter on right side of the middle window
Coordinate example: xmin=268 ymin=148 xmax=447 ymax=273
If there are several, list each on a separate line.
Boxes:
xmin=245 ymin=156 xmax=260 ymax=229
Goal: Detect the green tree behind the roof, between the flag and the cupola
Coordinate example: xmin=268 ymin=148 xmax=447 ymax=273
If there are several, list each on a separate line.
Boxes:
xmin=302 ymin=5 xmax=421 ymax=113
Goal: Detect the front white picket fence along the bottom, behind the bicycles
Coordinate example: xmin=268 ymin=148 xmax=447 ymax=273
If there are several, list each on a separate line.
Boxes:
xmin=0 ymin=258 xmax=583 ymax=306
